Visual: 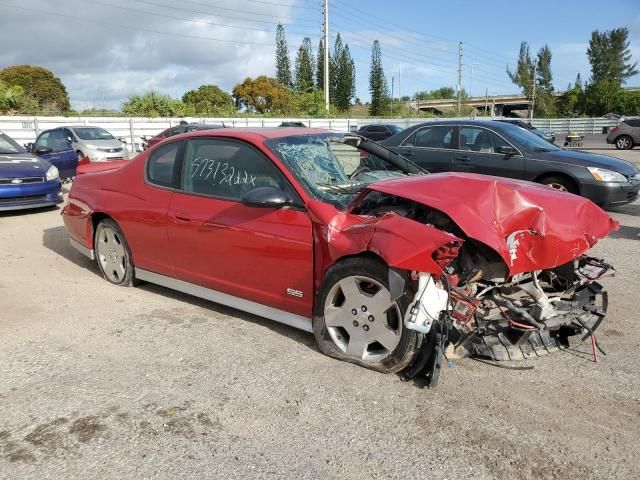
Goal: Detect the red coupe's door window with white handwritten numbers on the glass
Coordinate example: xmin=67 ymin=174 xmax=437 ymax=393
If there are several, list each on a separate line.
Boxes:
xmin=182 ymin=138 xmax=297 ymax=201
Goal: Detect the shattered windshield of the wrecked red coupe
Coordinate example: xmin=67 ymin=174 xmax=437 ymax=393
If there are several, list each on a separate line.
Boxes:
xmin=265 ymin=133 xmax=404 ymax=208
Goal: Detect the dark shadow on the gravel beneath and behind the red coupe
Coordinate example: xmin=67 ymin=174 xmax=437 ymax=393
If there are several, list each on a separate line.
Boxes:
xmin=42 ymin=226 xmax=318 ymax=351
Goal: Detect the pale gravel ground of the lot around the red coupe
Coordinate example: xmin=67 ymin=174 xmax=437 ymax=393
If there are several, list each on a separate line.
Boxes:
xmin=0 ymin=151 xmax=640 ymax=479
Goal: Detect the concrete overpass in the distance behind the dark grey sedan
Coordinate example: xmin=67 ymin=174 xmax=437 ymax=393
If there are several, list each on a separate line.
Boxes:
xmin=407 ymin=95 xmax=529 ymax=117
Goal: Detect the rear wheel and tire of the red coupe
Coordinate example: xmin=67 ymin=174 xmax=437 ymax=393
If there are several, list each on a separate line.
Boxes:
xmin=93 ymin=218 xmax=135 ymax=287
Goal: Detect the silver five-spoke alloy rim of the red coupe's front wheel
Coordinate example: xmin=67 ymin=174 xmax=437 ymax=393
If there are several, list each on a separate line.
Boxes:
xmin=324 ymin=276 xmax=402 ymax=363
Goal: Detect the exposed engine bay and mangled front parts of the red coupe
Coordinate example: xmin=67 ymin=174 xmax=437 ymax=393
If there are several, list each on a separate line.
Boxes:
xmin=351 ymin=191 xmax=615 ymax=386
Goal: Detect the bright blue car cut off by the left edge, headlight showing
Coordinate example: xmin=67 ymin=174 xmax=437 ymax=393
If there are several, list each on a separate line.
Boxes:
xmin=0 ymin=132 xmax=62 ymax=211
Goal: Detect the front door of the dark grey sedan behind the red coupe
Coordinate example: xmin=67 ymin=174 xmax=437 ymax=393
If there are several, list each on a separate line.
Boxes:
xmin=453 ymin=125 xmax=525 ymax=179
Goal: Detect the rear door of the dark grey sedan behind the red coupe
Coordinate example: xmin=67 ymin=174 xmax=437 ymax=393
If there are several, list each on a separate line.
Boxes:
xmin=391 ymin=125 xmax=455 ymax=173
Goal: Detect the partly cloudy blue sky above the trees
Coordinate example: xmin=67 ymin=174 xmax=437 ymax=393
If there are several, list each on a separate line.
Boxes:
xmin=0 ymin=0 xmax=640 ymax=109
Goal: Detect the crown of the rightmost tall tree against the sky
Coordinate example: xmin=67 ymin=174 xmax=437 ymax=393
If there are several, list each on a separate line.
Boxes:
xmin=587 ymin=28 xmax=638 ymax=85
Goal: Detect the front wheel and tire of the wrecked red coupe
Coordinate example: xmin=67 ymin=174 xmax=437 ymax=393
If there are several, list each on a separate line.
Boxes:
xmin=313 ymin=257 xmax=419 ymax=373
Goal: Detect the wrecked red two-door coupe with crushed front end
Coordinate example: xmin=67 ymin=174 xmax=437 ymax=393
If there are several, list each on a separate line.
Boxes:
xmin=63 ymin=128 xmax=617 ymax=385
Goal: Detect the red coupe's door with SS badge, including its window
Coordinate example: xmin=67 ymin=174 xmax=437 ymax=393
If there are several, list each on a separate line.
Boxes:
xmin=168 ymin=137 xmax=313 ymax=317
